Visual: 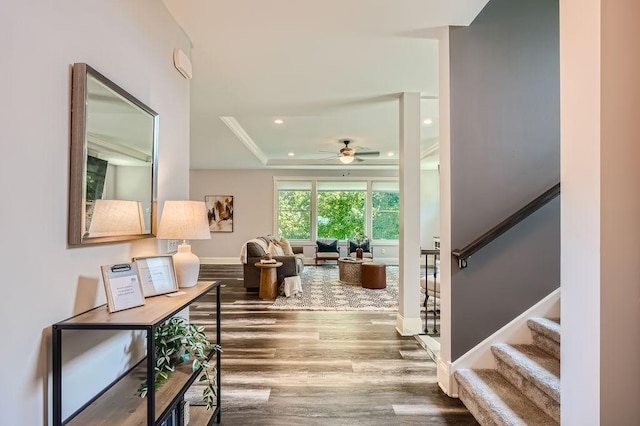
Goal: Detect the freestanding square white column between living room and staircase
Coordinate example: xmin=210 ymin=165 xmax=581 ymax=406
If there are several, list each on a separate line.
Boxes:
xmin=396 ymin=93 xmax=424 ymax=336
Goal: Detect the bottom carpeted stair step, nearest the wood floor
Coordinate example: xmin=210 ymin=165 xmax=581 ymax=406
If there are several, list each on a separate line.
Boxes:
xmin=455 ymin=369 xmax=558 ymax=426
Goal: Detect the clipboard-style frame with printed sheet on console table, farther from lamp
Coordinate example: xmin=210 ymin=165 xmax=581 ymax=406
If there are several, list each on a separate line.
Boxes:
xmin=101 ymin=262 xmax=144 ymax=313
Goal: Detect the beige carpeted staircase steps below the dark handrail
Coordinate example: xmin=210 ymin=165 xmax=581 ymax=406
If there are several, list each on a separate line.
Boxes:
xmin=455 ymin=318 xmax=560 ymax=425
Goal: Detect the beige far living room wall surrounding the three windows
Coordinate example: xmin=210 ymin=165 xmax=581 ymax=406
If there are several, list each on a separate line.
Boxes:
xmin=190 ymin=169 xmax=398 ymax=263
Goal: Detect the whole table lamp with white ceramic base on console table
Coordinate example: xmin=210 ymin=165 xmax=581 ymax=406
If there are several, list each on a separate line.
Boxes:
xmin=157 ymin=201 xmax=211 ymax=287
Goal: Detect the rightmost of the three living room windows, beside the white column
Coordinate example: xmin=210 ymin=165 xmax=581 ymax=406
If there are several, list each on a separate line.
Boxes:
xmin=371 ymin=182 xmax=400 ymax=240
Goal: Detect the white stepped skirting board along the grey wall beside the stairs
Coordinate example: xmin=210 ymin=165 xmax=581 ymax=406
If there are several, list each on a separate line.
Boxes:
xmin=438 ymin=288 xmax=560 ymax=396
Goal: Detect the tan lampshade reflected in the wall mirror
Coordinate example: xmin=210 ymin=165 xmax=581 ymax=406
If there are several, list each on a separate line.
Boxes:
xmin=89 ymin=200 xmax=144 ymax=237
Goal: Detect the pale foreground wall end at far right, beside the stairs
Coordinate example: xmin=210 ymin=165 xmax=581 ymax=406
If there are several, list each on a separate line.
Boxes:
xmin=560 ymin=0 xmax=640 ymax=425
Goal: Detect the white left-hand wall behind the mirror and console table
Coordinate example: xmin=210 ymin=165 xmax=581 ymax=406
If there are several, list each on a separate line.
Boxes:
xmin=0 ymin=0 xmax=190 ymax=425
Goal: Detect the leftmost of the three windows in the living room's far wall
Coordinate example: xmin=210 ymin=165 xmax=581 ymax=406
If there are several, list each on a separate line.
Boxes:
xmin=277 ymin=182 xmax=311 ymax=240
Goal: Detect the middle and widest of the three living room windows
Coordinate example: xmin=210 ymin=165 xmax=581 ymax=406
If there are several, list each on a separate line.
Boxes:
xmin=317 ymin=182 xmax=367 ymax=240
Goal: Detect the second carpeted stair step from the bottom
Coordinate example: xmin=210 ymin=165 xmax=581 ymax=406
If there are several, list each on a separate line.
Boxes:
xmin=491 ymin=343 xmax=560 ymax=403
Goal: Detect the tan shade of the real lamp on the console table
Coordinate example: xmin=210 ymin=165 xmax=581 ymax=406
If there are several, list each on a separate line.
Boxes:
xmin=157 ymin=201 xmax=211 ymax=240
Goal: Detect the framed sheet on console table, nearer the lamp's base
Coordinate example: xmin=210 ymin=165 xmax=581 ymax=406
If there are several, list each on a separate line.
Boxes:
xmin=133 ymin=255 xmax=178 ymax=297
